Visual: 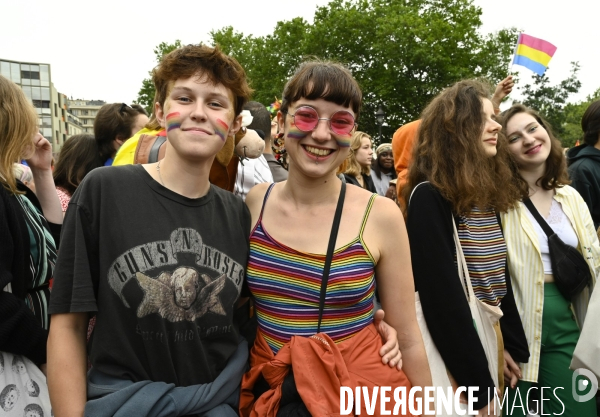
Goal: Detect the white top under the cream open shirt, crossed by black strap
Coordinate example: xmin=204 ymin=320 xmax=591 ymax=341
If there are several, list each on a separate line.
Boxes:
xmin=527 ymin=198 xmax=579 ymax=275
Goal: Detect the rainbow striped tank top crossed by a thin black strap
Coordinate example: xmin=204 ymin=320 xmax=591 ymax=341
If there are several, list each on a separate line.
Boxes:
xmin=246 ymin=184 xmax=377 ymax=353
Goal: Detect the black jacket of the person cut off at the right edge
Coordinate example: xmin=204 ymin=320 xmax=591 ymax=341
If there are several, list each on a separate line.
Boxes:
xmin=567 ymin=144 xmax=600 ymax=229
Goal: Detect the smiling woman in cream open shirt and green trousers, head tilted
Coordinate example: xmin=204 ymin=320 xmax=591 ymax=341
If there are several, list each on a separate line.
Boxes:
xmin=501 ymin=104 xmax=600 ymax=417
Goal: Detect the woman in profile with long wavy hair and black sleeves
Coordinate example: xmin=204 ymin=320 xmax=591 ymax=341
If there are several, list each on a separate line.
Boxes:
xmin=403 ymin=80 xmax=528 ymax=415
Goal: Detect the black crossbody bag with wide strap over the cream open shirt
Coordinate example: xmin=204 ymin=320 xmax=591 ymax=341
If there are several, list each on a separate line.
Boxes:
xmin=523 ymin=199 xmax=592 ymax=301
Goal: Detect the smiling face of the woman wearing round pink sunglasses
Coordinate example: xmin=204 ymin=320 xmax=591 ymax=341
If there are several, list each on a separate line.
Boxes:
xmin=277 ymin=98 xmax=354 ymax=177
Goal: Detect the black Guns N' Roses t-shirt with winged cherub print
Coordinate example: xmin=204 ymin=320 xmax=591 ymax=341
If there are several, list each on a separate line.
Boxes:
xmin=50 ymin=165 xmax=250 ymax=386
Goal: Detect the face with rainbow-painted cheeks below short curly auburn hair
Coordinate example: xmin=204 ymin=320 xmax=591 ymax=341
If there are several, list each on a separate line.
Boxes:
xmin=156 ymin=74 xmax=242 ymax=160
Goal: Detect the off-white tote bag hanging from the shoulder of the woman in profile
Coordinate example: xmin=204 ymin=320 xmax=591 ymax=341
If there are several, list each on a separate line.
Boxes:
xmin=409 ymin=183 xmax=502 ymax=417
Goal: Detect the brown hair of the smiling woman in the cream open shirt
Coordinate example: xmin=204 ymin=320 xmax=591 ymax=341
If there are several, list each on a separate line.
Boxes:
xmin=499 ymin=104 xmax=571 ymax=193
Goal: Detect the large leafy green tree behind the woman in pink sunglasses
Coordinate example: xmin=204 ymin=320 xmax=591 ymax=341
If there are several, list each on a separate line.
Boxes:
xmin=211 ymin=0 xmax=517 ymax=142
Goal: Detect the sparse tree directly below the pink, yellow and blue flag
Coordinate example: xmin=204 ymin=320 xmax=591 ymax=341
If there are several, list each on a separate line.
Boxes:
xmin=523 ymin=62 xmax=581 ymax=146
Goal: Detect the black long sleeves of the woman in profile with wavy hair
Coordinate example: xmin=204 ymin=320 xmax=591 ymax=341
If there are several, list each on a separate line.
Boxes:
xmin=406 ymin=183 xmax=529 ymax=409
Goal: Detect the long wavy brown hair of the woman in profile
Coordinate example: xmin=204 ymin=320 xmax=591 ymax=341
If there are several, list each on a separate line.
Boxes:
xmin=402 ymin=80 xmax=521 ymax=214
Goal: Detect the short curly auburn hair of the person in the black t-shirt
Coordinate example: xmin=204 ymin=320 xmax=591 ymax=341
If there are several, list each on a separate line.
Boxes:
xmin=146 ymin=45 xmax=252 ymax=130
